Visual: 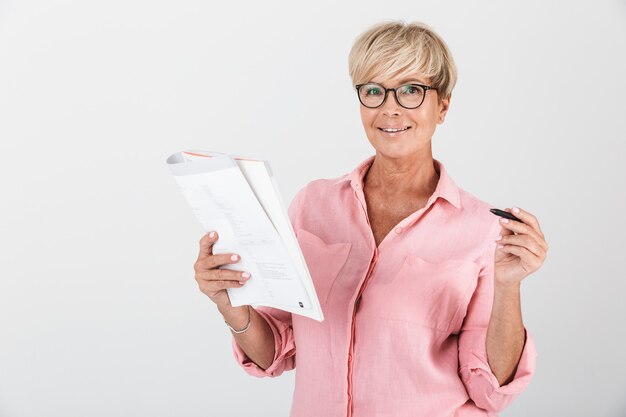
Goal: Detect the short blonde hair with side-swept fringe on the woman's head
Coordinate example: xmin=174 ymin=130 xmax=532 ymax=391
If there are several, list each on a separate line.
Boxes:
xmin=348 ymin=21 xmax=457 ymax=101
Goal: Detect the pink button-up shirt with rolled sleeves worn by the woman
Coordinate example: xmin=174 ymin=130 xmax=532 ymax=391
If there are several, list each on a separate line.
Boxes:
xmin=232 ymin=157 xmax=536 ymax=417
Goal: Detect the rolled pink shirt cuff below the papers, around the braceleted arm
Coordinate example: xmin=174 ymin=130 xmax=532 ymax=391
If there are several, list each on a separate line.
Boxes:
xmin=232 ymin=309 xmax=296 ymax=378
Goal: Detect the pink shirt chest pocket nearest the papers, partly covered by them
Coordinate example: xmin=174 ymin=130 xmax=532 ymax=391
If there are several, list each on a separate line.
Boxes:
xmin=296 ymin=229 xmax=352 ymax=305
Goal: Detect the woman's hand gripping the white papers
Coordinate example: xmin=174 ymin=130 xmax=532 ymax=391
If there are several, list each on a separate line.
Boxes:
xmin=193 ymin=232 xmax=250 ymax=307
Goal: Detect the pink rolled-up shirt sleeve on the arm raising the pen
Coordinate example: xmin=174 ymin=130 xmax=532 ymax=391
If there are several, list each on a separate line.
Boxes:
xmin=459 ymin=218 xmax=537 ymax=412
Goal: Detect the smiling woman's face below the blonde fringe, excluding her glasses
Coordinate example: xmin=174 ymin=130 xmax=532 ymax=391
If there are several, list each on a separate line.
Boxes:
xmin=359 ymin=74 xmax=450 ymax=158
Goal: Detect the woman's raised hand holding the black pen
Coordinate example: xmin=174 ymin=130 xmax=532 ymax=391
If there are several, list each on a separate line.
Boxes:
xmin=494 ymin=208 xmax=548 ymax=285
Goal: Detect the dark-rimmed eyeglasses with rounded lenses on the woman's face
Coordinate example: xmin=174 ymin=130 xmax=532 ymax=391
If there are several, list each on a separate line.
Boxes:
xmin=355 ymin=83 xmax=436 ymax=109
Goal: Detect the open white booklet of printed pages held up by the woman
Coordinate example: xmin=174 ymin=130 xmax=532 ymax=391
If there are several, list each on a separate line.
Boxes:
xmin=167 ymin=150 xmax=324 ymax=322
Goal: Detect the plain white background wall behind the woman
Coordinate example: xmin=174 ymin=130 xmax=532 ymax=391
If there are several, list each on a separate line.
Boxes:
xmin=0 ymin=0 xmax=626 ymax=417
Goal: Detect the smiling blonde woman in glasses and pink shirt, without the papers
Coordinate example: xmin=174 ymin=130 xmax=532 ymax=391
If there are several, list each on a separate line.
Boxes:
xmin=195 ymin=22 xmax=548 ymax=417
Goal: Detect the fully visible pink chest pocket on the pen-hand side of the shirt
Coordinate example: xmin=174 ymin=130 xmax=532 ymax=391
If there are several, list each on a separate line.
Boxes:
xmin=382 ymin=255 xmax=479 ymax=333
